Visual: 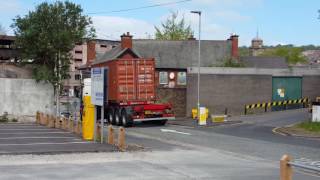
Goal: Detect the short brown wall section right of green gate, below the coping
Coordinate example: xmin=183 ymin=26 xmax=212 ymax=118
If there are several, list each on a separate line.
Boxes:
xmin=302 ymin=75 xmax=320 ymax=101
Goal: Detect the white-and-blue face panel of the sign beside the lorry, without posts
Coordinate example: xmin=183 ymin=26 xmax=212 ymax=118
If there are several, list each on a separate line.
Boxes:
xmin=91 ymin=68 xmax=105 ymax=106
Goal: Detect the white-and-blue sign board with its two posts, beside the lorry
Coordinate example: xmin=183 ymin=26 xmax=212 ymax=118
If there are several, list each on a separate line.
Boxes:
xmin=91 ymin=68 xmax=106 ymax=143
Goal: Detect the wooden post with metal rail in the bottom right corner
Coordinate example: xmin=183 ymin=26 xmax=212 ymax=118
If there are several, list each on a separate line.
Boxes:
xmin=280 ymin=155 xmax=320 ymax=180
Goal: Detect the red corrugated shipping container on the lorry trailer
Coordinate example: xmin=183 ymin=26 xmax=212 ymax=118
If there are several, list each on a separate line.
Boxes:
xmin=92 ymin=58 xmax=156 ymax=103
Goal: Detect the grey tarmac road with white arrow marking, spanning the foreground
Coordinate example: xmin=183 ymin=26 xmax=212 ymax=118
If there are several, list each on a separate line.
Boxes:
xmin=0 ymin=111 xmax=320 ymax=180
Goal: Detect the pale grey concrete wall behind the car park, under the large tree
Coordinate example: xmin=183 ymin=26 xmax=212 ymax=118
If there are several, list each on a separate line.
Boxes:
xmin=0 ymin=78 xmax=54 ymax=120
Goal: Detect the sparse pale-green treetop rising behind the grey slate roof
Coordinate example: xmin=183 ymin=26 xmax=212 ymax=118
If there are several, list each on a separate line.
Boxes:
xmin=155 ymin=12 xmax=193 ymax=40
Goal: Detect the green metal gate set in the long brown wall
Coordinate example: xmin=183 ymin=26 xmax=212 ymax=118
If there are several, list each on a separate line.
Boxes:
xmin=272 ymin=77 xmax=302 ymax=110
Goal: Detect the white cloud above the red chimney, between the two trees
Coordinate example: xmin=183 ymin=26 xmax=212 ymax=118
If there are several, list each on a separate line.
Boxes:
xmin=92 ymin=16 xmax=154 ymax=40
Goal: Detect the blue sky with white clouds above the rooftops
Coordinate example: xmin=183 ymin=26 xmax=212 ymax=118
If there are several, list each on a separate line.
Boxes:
xmin=0 ymin=0 xmax=320 ymax=45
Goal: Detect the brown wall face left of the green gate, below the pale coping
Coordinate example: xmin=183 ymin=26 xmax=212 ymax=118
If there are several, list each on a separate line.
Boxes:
xmin=187 ymin=74 xmax=272 ymax=116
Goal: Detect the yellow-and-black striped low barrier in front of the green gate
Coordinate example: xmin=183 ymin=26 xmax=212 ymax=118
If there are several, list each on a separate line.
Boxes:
xmin=244 ymin=98 xmax=309 ymax=114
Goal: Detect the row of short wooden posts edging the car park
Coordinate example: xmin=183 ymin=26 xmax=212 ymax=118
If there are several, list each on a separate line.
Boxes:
xmin=36 ymin=112 xmax=126 ymax=151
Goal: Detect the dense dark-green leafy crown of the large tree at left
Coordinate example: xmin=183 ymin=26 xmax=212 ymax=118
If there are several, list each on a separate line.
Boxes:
xmin=12 ymin=1 xmax=95 ymax=87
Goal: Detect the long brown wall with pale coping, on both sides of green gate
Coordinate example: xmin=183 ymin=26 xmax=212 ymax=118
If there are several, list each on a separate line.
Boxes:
xmin=186 ymin=67 xmax=320 ymax=116
